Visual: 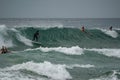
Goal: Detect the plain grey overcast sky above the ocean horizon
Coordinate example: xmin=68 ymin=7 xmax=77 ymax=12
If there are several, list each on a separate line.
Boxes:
xmin=0 ymin=0 xmax=120 ymax=18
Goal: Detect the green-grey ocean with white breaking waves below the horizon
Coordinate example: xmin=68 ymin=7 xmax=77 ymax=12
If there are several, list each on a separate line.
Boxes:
xmin=0 ymin=18 xmax=120 ymax=80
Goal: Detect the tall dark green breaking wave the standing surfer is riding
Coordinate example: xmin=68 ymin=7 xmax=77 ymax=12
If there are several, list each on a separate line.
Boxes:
xmin=0 ymin=25 xmax=120 ymax=49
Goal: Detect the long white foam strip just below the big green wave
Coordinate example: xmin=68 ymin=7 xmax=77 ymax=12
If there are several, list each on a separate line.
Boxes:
xmin=25 ymin=46 xmax=120 ymax=58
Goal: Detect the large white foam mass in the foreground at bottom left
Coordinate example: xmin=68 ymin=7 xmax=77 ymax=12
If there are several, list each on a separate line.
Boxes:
xmin=0 ymin=61 xmax=94 ymax=80
